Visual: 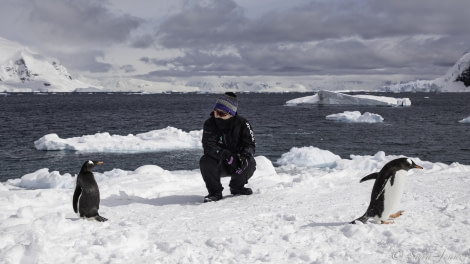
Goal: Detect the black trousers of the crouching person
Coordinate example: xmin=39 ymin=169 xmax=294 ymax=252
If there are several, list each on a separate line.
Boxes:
xmin=199 ymin=155 xmax=256 ymax=194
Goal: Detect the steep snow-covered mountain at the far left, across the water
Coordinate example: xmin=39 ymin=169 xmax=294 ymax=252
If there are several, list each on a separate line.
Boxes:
xmin=0 ymin=38 xmax=100 ymax=92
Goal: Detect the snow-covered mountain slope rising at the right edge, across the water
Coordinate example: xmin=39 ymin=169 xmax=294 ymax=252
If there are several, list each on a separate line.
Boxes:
xmin=380 ymin=52 xmax=470 ymax=92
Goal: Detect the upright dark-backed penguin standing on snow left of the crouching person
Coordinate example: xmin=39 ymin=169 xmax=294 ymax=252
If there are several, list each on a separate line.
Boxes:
xmin=73 ymin=160 xmax=108 ymax=222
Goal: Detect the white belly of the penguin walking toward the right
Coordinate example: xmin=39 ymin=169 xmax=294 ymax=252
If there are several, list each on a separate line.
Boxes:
xmin=380 ymin=170 xmax=408 ymax=220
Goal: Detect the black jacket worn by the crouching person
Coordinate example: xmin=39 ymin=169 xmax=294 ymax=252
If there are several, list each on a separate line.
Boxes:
xmin=202 ymin=113 xmax=255 ymax=159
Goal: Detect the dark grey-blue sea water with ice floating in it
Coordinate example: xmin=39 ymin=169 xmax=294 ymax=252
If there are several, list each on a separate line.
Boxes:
xmin=0 ymin=93 xmax=470 ymax=181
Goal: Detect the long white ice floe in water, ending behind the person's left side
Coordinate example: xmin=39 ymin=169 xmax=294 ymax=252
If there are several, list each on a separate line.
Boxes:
xmin=34 ymin=127 xmax=202 ymax=153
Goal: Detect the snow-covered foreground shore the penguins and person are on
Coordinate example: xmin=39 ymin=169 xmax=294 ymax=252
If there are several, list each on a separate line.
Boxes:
xmin=0 ymin=147 xmax=470 ymax=263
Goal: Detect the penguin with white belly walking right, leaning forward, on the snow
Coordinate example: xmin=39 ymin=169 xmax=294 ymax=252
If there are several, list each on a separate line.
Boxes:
xmin=351 ymin=158 xmax=423 ymax=224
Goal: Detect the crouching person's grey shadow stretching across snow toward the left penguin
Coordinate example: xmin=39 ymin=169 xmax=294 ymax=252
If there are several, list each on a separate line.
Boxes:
xmin=100 ymin=191 xmax=201 ymax=207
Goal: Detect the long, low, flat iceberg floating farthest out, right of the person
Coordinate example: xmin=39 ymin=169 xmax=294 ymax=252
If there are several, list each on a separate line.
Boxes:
xmin=286 ymin=90 xmax=411 ymax=106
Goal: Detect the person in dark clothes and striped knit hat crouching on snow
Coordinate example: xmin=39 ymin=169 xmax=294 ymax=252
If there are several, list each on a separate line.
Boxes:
xmin=199 ymin=92 xmax=256 ymax=202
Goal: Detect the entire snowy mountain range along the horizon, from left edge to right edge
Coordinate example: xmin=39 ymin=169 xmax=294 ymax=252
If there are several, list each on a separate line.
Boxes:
xmin=0 ymin=37 xmax=470 ymax=93
